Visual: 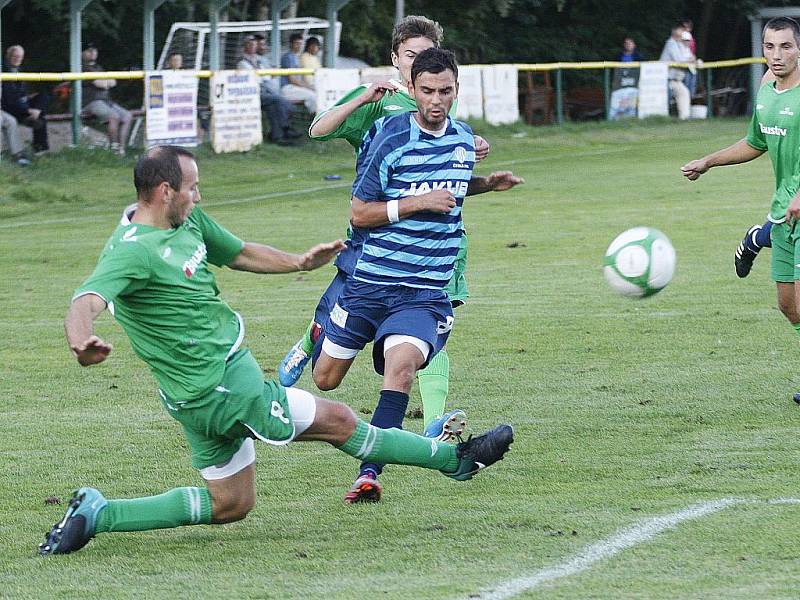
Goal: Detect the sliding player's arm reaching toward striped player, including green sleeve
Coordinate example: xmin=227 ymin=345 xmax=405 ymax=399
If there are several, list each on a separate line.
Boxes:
xmin=195 ymin=208 xmax=345 ymax=273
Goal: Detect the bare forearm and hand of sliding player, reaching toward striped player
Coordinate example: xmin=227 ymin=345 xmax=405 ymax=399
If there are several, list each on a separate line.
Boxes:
xmin=228 ymin=240 xmax=345 ymax=273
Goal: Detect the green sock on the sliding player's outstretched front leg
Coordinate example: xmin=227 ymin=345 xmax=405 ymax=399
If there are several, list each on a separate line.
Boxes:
xmin=339 ymin=419 xmax=458 ymax=472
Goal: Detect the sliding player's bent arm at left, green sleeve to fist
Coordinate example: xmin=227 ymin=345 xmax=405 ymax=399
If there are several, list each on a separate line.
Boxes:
xmin=64 ymin=242 xmax=150 ymax=367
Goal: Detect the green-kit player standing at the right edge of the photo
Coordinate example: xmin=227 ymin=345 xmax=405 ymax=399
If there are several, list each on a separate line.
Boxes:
xmin=681 ymin=17 xmax=800 ymax=401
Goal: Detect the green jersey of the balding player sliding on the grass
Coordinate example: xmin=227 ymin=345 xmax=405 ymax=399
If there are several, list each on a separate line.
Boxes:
xmin=74 ymin=207 xmax=244 ymax=402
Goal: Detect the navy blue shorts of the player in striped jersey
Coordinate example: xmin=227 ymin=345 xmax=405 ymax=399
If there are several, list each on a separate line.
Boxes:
xmin=325 ymin=278 xmax=453 ymax=375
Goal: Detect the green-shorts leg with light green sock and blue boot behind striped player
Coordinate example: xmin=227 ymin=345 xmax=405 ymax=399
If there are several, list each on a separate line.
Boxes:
xmin=417 ymin=234 xmax=469 ymax=441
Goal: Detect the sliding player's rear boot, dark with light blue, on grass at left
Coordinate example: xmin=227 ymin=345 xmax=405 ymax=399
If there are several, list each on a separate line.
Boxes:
xmin=39 ymin=487 xmax=108 ymax=556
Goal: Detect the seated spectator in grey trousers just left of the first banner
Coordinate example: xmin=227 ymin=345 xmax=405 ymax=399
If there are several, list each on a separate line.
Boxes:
xmin=81 ymin=44 xmax=131 ymax=155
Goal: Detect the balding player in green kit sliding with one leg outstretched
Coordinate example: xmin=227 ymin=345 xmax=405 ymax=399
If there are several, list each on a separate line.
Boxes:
xmin=39 ymin=146 xmax=513 ymax=555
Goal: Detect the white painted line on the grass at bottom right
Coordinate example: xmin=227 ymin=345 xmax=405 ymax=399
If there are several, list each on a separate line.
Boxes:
xmin=478 ymin=498 xmax=800 ymax=600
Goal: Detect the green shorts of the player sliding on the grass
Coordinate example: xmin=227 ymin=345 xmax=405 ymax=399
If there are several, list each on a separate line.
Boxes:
xmin=161 ymin=350 xmax=295 ymax=469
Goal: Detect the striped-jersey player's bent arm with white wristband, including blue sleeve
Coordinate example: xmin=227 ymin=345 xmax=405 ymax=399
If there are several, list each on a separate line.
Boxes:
xmin=350 ymin=128 xmax=456 ymax=229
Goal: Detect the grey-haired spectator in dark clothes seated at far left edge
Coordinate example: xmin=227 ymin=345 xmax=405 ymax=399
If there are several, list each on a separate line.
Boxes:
xmin=0 ymin=46 xmax=50 ymax=154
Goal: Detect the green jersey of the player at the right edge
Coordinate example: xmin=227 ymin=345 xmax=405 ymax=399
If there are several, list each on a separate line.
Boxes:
xmin=746 ymin=82 xmax=800 ymax=223
